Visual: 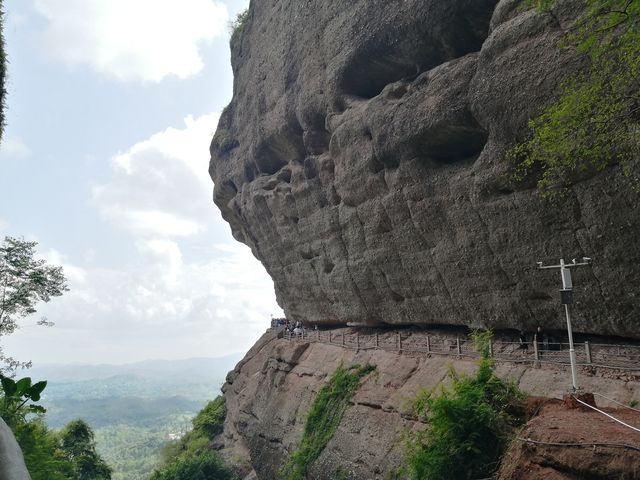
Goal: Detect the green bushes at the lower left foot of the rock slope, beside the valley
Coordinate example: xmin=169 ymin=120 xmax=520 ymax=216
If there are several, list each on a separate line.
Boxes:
xmin=150 ymin=396 xmax=233 ymax=480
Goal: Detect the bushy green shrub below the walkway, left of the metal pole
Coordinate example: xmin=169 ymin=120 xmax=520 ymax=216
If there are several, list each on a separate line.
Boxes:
xmin=407 ymin=334 xmax=524 ymax=480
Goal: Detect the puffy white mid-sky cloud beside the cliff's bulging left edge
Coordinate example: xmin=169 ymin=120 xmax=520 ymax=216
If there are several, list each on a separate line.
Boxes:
xmin=93 ymin=113 xmax=219 ymax=236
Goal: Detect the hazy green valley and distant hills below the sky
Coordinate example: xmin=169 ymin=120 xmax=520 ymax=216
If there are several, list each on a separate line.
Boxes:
xmin=20 ymin=353 xmax=243 ymax=480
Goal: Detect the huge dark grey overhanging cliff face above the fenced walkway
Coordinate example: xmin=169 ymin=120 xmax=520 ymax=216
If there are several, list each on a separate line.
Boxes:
xmin=210 ymin=0 xmax=640 ymax=337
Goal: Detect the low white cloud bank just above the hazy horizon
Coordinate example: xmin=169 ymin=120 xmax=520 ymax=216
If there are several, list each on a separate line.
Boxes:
xmin=4 ymin=239 xmax=280 ymax=363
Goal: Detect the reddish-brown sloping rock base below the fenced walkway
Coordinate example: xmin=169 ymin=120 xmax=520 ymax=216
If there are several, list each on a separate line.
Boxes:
xmin=221 ymin=331 xmax=640 ymax=480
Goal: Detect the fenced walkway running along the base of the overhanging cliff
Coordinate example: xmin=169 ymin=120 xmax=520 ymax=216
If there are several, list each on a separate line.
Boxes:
xmin=279 ymin=328 xmax=640 ymax=375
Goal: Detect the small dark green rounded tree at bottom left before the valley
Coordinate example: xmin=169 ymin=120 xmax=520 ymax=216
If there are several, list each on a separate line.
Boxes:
xmin=60 ymin=420 xmax=111 ymax=480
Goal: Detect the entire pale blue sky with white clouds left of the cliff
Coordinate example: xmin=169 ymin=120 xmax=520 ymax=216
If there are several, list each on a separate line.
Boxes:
xmin=0 ymin=0 xmax=281 ymax=363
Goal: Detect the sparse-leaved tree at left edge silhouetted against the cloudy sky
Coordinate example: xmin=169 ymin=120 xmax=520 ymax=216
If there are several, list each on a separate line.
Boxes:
xmin=0 ymin=236 xmax=68 ymax=371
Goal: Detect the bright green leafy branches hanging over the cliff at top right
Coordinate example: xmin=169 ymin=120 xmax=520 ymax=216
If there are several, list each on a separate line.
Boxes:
xmin=510 ymin=0 xmax=640 ymax=194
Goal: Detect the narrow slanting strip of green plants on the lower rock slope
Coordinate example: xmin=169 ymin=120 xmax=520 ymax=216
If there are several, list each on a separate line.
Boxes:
xmin=281 ymin=365 xmax=375 ymax=480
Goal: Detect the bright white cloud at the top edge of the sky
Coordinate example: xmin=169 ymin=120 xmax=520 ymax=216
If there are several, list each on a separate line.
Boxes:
xmin=34 ymin=0 xmax=229 ymax=82
